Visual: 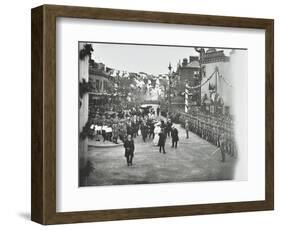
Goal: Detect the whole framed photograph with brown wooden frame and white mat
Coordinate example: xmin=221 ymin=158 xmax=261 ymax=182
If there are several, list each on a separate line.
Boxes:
xmin=31 ymin=5 xmax=274 ymax=224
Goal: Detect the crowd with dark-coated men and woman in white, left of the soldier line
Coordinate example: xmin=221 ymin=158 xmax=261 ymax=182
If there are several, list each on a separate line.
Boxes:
xmin=89 ymin=107 xmax=182 ymax=166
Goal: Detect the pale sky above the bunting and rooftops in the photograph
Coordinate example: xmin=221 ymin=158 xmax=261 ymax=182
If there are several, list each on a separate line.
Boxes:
xmin=88 ymin=43 xmax=230 ymax=75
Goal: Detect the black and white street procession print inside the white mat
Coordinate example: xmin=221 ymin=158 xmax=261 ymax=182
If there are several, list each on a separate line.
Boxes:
xmin=77 ymin=41 xmax=248 ymax=187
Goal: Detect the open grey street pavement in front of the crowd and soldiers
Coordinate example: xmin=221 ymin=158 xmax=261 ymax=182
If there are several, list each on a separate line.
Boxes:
xmin=83 ymin=122 xmax=236 ymax=186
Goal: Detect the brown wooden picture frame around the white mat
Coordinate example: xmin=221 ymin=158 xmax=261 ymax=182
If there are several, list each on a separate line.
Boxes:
xmin=31 ymin=5 xmax=274 ymax=224
